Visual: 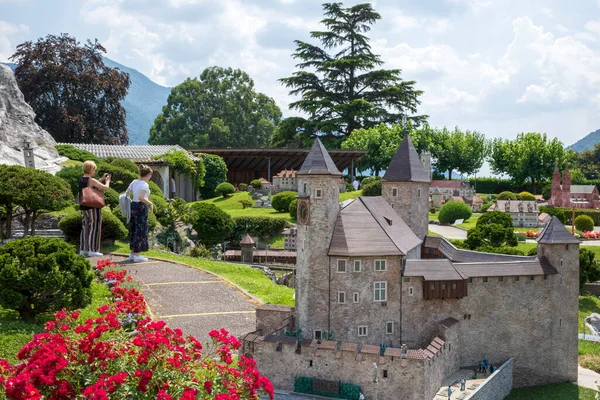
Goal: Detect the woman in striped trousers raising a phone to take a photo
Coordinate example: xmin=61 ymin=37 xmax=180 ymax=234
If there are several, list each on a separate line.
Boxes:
xmin=79 ymin=160 xmax=110 ymax=257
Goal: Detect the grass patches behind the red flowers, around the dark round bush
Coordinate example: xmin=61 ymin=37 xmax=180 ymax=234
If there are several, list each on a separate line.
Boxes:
xmin=0 ymin=280 xmax=110 ymax=363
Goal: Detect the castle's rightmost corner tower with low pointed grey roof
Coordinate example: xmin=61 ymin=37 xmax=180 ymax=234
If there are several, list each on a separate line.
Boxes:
xmin=537 ymin=217 xmax=580 ymax=381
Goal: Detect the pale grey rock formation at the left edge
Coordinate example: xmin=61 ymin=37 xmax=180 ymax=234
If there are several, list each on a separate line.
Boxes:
xmin=0 ymin=65 xmax=65 ymax=173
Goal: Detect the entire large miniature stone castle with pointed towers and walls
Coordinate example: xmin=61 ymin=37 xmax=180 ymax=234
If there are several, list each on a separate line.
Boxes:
xmin=243 ymin=137 xmax=579 ymax=400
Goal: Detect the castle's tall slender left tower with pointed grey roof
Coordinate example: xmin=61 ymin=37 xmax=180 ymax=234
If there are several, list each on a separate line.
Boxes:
xmin=295 ymin=139 xmax=342 ymax=338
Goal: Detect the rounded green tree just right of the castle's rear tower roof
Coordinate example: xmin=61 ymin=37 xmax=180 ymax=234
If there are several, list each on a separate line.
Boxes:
xmin=432 ymin=127 xmax=488 ymax=179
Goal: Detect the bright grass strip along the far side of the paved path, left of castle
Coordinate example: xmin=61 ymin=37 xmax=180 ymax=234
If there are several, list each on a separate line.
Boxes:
xmin=109 ymin=242 xmax=295 ymax=306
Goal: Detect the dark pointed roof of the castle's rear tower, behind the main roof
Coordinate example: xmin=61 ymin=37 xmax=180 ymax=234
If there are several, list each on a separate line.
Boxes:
xmin=382 ymin=135 xmax=431 ymax=182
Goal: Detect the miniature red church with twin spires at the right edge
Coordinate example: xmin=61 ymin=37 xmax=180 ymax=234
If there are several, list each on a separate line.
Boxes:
xmin=548 ymin=164 xmax=600 ymax=208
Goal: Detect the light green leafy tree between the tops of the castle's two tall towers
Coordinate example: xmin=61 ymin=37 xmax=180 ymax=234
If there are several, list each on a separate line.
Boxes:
xmin=342 ymin=122 xmax=434 ymax=175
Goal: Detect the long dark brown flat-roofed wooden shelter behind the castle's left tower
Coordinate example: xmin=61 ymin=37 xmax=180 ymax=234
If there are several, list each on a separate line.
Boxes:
xmin=187 ymin=149 xmax=366 ymax=184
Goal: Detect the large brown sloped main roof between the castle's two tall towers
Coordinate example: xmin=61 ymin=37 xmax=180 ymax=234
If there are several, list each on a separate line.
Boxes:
xmin=327 ymin=196 xmax=421 ymax=256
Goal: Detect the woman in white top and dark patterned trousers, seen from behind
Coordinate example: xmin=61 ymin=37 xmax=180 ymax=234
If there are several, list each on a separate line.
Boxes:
xmin=125 ymin=164 xmax=154 ymax=262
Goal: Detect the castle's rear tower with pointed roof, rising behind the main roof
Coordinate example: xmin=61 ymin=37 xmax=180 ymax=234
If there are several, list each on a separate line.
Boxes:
xmin=381 ymin=135 xmax=431 ymax=240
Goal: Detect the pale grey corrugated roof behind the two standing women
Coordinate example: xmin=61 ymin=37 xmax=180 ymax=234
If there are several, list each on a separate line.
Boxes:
xmin=61 ymin=143 xmax=198 ymax=162
